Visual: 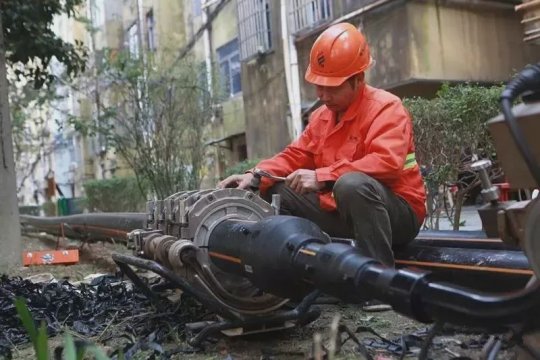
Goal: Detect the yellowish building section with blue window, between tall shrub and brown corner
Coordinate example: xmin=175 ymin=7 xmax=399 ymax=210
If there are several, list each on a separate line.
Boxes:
xmin=186 ymin=0 xmax=247 ymax=187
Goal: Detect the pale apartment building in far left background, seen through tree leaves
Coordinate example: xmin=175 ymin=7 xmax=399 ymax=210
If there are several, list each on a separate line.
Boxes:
xmin=42 ymin=0 xmax=190 ymax=205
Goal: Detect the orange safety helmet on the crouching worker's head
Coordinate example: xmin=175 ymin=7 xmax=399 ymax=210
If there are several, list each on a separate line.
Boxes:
xmin=305 ymin=23 xmax=373 ymax=86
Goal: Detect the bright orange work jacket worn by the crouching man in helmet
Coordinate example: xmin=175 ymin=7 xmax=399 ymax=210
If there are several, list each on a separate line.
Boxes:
xmin=257 ymin=85 xmax=426 ymax=223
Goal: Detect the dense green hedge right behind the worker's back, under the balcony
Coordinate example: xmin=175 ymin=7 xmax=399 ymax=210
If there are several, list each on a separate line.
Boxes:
xmin=404 ymin=84 xmax=502 ymax=230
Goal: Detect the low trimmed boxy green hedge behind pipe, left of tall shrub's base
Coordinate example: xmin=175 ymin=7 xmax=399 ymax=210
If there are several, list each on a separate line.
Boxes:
xmin=83 ymin=177 xmax=146 ymax=212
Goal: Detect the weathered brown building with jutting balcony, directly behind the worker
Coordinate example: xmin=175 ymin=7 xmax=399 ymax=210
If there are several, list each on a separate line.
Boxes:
xmin=237 ymin=0 xmax=540 ymax=157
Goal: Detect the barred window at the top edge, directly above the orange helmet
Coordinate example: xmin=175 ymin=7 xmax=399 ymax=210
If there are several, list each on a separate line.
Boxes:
xmin=289 ymin=0 xmax=331 ymax=33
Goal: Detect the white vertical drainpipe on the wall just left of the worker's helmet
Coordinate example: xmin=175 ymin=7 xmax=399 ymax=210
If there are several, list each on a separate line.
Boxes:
xmin=280 ymin=0 xmax=303 ymax=139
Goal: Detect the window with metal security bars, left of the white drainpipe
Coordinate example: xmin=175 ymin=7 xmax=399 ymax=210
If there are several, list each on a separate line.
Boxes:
xmin=236 ymin=0 xmax=272 ymax=61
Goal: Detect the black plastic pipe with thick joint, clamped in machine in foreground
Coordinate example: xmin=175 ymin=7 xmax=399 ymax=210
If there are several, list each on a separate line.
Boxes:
xmin=208 ymin=216 xmax=540 ymax=329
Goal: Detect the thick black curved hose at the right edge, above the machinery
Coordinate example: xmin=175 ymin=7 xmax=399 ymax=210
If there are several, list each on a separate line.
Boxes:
xmin=501 ymin=63 xmax=540 ymax=185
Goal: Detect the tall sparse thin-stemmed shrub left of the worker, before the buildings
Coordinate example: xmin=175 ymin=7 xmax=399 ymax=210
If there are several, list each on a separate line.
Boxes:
xmin=70 ymin=51 xmax=217 ymax=198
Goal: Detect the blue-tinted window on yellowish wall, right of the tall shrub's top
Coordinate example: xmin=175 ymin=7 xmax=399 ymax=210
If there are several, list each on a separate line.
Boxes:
xmin=217 ymin=39 xmax=242 ymax=96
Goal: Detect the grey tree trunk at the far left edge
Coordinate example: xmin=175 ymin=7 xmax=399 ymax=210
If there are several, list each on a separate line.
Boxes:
xmin=0 ymin=16 xmax=22 ymax=273
